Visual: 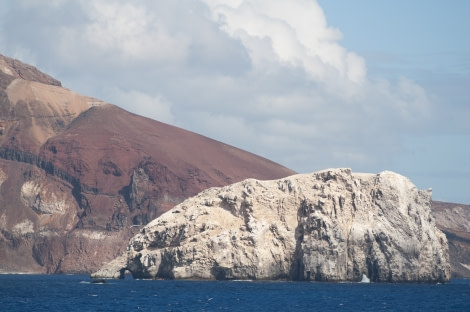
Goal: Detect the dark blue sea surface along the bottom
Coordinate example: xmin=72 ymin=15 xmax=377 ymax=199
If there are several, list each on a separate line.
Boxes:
xmin=0 ymin=274 xmax=470 ymax=312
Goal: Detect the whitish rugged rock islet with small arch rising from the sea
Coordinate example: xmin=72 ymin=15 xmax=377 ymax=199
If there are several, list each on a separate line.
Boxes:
xmin=93 ymin=169 xmax=450 ymax=282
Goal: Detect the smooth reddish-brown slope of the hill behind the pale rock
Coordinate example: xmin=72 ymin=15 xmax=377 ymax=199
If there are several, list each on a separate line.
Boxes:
xmin=40 ymin=105 xmax=293 ymax=193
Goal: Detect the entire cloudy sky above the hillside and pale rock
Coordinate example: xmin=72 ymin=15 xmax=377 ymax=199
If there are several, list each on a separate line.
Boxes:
xmin=0 ymin=0 xmax=470 ymax=204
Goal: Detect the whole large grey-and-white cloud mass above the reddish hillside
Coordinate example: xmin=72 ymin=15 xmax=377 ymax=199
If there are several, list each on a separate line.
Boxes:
xmin=0 ymin=0 xmax=432 ymax=172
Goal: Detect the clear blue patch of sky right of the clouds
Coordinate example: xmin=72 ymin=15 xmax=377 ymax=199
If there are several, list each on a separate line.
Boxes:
xmin=319 ymin=0 xmax=470 ymax=204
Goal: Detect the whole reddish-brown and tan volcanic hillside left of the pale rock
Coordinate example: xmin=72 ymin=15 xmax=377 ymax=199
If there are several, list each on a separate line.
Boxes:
xmin=0 ymin=55 xmax=294 ymax=273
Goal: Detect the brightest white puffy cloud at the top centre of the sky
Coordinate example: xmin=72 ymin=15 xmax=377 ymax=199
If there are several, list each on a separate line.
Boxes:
xmin=202 ymin=0 xmax=365 ymax=82
